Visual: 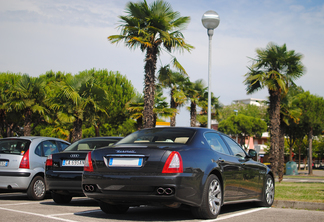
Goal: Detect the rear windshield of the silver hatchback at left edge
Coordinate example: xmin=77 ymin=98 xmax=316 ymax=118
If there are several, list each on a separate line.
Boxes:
xmin=0 ymin=139 xmax=30 ymax=155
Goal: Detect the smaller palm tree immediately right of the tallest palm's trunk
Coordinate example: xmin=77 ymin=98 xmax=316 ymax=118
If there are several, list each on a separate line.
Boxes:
xmin=158 ymin=65 xmax=188 ymax=127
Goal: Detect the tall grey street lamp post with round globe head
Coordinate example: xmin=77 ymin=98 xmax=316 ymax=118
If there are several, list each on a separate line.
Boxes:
xmin=201 ymin=10 xmax=220 ymax=129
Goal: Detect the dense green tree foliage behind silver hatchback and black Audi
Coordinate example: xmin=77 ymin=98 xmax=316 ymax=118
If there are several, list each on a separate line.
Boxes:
xmin=0 ymin=69 xmax=135 ymax=141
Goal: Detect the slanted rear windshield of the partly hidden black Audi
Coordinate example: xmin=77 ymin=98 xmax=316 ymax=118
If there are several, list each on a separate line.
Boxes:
xmin=63 ymin=138 xmax=120 ymax=152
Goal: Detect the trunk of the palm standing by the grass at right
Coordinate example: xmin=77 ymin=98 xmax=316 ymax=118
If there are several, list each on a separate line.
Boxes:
xmin=269 ymin=90 xmax=280 ymax=178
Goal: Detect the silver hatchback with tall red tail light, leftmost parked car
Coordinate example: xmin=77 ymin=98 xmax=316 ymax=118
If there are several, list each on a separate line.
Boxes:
xmin=0 ymin=136 xmax=70 ymax=200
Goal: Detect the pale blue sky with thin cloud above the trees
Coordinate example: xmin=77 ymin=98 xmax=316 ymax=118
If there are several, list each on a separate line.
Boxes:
xmin=0 ymin=0 xmax=324 ymax=126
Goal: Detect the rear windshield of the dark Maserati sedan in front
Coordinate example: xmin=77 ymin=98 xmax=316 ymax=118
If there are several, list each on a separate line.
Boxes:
xmin=117 ymin=127 xmax=195 ymax=144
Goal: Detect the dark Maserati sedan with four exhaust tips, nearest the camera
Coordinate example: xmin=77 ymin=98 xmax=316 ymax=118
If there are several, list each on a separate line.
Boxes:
xmin=82 ymin=127 xmax=275 ymax=219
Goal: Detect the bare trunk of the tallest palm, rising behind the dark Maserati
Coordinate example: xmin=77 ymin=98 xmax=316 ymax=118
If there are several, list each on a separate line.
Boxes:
xmin=143 ymin=46 xmax=157 ymax=128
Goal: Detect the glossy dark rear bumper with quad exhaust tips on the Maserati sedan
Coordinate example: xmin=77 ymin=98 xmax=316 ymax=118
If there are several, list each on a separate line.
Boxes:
xmin=82 ymin=173 xmax=201 ymax=206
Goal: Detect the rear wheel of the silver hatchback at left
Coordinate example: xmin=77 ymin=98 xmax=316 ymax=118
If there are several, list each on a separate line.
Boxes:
xmin=27 ymin=176 xmax=46 ymax=200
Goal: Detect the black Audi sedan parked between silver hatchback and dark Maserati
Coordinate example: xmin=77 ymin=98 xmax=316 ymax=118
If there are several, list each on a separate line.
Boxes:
xmin=45 ymin=137 xmax=122 ymax=204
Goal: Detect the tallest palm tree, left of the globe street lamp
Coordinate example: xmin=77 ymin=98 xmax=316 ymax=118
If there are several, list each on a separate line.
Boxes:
xmin=108 ymin=0 xmax=193 ymax=128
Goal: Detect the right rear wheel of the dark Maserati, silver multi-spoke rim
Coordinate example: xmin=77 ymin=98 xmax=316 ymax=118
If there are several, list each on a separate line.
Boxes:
xmin=192 ymin=174 xmax=223 ymax=219
